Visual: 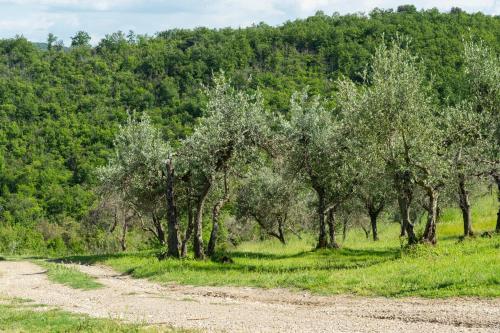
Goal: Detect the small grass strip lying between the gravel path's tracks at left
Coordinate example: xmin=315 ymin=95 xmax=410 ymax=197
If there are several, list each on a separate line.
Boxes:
xmin=34 ymin=260 xmax=103 ymax=290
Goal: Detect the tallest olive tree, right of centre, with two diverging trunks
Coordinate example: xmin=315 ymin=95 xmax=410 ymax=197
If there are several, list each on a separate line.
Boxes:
xmin=341 ymin=39 xmax=447 ymax=244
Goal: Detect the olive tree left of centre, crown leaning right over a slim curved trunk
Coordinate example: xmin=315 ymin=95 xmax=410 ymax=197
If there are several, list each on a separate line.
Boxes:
xmin=179 ymin=75 xmax=268 ymax=259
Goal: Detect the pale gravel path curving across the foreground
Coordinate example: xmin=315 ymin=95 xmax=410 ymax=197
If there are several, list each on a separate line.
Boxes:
xmin=0 ymin=261 xmax=500 ymax=333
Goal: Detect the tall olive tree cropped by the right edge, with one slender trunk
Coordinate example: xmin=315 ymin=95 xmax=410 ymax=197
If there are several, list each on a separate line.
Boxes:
xmin=446 ymin=41 xmax=500 ymax=237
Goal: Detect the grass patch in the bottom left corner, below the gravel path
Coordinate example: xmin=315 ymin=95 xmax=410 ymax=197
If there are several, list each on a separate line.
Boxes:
xmin=0 ymin=299 xmax=187 ymax=333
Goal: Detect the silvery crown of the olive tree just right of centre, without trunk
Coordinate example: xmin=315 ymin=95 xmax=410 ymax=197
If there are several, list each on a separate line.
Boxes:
xmin=284 ymin=90 xmax=353 ymax=200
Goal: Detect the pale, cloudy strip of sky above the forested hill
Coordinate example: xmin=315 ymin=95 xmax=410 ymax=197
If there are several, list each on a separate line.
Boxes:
xmin=0 ymin=0 xmax=500 ymax=44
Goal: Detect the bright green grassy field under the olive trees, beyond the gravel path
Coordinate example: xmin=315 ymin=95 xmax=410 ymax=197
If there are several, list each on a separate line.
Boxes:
xmin=63 ymin=191 xmax=500 ymax=297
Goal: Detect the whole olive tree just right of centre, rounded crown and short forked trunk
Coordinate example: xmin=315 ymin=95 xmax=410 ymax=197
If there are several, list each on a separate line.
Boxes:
xmin=284 ymin=90 xmax=355 ymax=248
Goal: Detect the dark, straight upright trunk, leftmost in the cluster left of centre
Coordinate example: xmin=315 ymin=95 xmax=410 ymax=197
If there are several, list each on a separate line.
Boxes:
xmin=166 ymin=159 xmax=180 ymax=258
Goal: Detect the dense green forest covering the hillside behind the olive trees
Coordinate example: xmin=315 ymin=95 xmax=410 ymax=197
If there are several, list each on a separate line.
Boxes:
xmin=0 ymin=6 xmax=500 ymax=253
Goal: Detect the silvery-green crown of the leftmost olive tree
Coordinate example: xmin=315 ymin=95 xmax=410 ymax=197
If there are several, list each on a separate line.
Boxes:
xmin=98 ymin=114 xmax=172 ymax=211
